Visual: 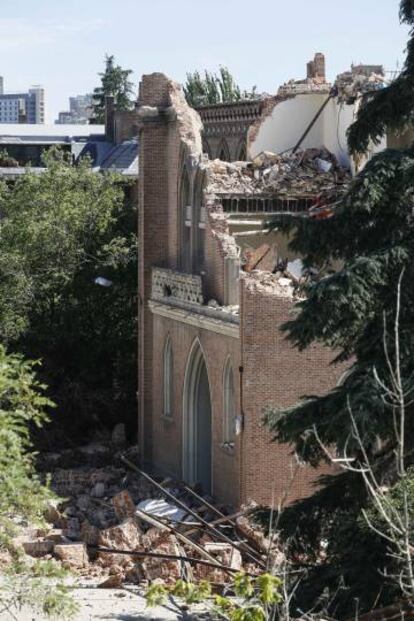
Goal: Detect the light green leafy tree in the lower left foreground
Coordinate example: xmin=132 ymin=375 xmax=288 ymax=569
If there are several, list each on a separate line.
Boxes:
xmin=0 ymin=345 xmax=77 ymax=619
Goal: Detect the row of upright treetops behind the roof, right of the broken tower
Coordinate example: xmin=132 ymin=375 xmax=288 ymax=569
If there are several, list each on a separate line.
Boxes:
xmin=184 ymin=67 xmax=256 ymax=108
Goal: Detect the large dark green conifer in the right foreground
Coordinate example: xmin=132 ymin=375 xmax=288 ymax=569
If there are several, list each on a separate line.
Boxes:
xmin=266 ymin=0 xmax=414 ymax=614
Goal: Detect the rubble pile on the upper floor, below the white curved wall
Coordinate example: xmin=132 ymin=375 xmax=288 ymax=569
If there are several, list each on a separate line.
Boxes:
xmin=205 ymin=148 xmax=351 ymax=199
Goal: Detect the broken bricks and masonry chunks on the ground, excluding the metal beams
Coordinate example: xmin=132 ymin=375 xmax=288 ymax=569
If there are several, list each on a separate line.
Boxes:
xmin=10 ymin=434 xmax=274 ymax=589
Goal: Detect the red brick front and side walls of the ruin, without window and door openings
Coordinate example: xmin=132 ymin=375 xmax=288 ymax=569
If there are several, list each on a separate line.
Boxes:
xmin=138 ymin=74 xmax=338 ymax=506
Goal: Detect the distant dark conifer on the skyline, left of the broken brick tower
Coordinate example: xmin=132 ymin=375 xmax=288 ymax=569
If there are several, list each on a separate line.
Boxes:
xmin=92 ymin=54 xmax=134 ymax=124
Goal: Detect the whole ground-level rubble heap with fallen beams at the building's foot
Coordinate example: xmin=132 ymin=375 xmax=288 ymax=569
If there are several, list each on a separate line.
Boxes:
xmin=7 ymin=428 xmax=279 ymax=589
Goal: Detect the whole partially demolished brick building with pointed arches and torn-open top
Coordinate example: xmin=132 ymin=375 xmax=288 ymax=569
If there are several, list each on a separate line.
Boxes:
xmin=137 ymin=58 xmax=386 ymax=506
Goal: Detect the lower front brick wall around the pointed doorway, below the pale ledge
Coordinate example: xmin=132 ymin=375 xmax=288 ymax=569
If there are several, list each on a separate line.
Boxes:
xmin=152 ymin=315 xmax=240 ymax=505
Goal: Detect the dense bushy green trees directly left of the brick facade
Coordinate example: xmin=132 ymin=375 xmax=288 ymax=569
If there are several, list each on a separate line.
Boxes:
xmin=0 ymin=150 xmax=137 ymax=441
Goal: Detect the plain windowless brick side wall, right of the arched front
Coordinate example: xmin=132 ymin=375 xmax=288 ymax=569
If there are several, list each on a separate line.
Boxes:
xmin=241 ymin=279 xmax=344 ymax=505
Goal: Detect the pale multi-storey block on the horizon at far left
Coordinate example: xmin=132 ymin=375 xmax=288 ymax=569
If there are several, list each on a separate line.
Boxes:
xmin=0 ymin=77 xmax=45 ymax=124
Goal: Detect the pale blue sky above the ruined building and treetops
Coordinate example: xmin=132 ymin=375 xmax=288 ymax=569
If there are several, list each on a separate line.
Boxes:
xmin=0 ymin=0 xmax=408 ymax=122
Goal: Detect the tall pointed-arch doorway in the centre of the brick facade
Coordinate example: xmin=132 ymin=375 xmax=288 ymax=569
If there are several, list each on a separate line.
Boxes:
xmin=183 ymin=341 xmax=211 ymax=493
